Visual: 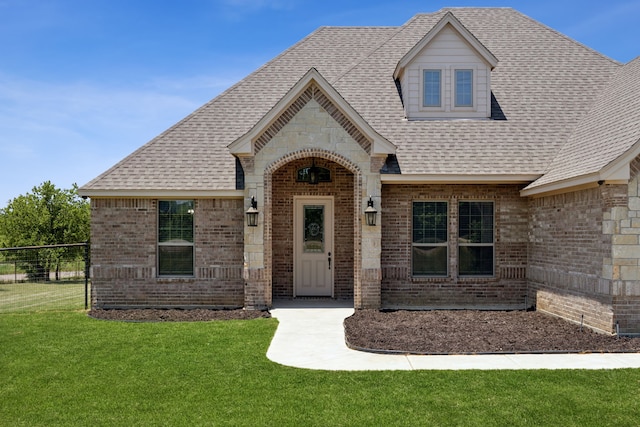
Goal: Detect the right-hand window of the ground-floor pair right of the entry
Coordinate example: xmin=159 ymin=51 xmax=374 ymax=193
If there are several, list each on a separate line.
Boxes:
xmin=458 ymin=202 xmax=494 ymax=276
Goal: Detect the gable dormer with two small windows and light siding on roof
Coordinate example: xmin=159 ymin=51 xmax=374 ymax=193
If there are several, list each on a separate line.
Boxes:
xmin=394 ymin=12 xmax=498 ymax=120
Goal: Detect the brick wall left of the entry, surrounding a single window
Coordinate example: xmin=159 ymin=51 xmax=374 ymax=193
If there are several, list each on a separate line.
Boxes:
xmin=91 ymin=198 xmax=244 ymax=308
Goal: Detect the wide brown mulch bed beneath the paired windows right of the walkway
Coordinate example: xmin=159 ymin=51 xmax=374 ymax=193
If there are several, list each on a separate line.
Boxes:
xmin=344 ymin=310 xmax=640 ymax=354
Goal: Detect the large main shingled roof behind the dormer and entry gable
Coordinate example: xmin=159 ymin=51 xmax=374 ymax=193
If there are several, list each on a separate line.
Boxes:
xmin=81 ymin=8 xmax=624 ymax=196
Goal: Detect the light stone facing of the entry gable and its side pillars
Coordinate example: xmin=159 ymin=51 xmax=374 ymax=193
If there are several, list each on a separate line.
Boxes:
xmin=239 ymin=94 xmax=384 ymax=308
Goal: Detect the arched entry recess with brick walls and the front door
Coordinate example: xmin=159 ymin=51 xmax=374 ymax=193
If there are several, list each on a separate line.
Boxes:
xmin=265 ymin=155 xmax=360 ymax=300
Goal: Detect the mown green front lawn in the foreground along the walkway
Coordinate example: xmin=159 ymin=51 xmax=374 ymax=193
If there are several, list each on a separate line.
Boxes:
xmin=0 ymin=311 xmax=640 ymax=426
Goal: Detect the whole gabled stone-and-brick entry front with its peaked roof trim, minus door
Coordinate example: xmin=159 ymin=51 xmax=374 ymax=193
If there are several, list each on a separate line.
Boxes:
xmin=229 ymin=69 xmax=395 ymax=309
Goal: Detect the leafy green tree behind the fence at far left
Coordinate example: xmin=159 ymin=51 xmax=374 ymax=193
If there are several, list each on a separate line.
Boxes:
xmin=0 ymin=181 xmax=90 ymax=280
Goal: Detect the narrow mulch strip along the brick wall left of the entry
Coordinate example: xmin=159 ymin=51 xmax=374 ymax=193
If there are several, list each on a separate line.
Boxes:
xmin=89 ymin=308 xmax=271 ymax=322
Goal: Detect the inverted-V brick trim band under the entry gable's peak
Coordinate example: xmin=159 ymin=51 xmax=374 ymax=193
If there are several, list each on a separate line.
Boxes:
xmin=254 ymin=83 xmax=372 ymax=154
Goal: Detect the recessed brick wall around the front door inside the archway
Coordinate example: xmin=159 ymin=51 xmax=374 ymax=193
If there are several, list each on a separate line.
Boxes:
xmin=272 ymin=159 xmax=354 ymax=299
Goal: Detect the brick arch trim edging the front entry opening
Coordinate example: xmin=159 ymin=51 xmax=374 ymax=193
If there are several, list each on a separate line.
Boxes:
xmin=263 ymin=148 xmax=363 ymax=306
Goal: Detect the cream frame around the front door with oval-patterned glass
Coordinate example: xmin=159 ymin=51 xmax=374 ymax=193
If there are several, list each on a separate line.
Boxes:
xmin=293 ymin=195 xmax=335 ymax=298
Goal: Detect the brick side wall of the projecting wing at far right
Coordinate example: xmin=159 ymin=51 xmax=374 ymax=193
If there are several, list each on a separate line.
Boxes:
xmin=527 ymin=186 xmax=621 ymax=332
